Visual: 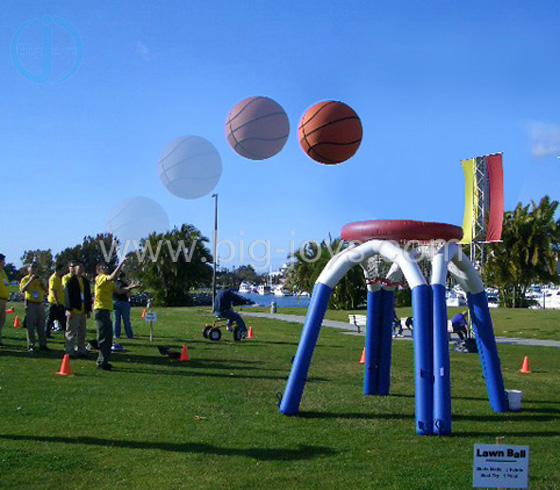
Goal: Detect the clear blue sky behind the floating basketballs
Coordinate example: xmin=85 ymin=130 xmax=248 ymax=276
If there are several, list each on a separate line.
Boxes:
xmin=0 ymin=0 xmax=560 ymax=267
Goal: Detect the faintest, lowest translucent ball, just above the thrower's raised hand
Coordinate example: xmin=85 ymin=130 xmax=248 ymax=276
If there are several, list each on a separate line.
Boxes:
xmin=107 ymin=197 xmax=169 ymax=252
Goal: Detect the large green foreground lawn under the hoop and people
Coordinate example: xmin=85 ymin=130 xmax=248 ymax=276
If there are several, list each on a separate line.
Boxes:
xmin=0 ymin=306 xmax=560 ymax=490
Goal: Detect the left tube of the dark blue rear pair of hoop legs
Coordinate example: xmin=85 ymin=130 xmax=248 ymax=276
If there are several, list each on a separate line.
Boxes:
xmin=364 ymin=290 xmax=383 ymax=395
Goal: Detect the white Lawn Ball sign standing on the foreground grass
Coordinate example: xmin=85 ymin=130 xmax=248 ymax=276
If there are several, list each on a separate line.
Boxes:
xmin=473 ymin=444 xmax=529 ymax=488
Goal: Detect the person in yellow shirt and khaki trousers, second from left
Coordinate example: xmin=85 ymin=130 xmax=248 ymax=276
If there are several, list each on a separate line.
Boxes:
xmin=19 ymin=264 xmax=49 ymax=352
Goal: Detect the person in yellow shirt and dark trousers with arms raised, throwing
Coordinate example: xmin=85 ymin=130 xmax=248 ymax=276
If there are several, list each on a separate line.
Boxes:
xmin=93 ymin=257 xmax=137 ymax=371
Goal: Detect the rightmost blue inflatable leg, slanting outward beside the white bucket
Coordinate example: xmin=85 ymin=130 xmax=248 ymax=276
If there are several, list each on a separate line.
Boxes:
xmin=467 ymin=291 xmax=509 ymax=412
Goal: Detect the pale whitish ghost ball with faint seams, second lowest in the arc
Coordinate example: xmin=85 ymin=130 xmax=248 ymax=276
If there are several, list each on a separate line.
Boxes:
xmin=158 ymin=136 xmax=222 ymax=199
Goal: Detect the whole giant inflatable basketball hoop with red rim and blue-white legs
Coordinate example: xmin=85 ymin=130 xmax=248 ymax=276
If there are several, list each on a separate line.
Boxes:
xmin=280 ymin=220 xmax=509 ymax=435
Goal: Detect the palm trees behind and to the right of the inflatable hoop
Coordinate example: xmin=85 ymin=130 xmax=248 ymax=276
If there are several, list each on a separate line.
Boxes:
xmin=289 ymin=196 xmax=560 ymax=309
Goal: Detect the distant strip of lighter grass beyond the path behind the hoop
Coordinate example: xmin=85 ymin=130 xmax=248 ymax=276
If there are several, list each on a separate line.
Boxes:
xmin=248 ymin=307 xmax=560 ymax=340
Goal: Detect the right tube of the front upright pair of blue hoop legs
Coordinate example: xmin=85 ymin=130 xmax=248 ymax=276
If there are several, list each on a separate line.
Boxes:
xmin=432 ymin=284 xmax=451 ymax=435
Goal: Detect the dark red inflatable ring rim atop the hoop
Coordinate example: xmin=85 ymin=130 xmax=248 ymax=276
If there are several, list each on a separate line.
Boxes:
xmin=341 ymin=219 xmax=463 ymax=242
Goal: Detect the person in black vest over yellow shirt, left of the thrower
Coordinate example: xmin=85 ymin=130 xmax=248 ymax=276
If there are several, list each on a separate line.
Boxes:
xmin=64 ymin=262 xmax=91 ymax=358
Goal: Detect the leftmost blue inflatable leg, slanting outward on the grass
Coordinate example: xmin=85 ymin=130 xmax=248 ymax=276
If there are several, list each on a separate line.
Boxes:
xmin=280 ymin=283 xmax=332 ymax=415
